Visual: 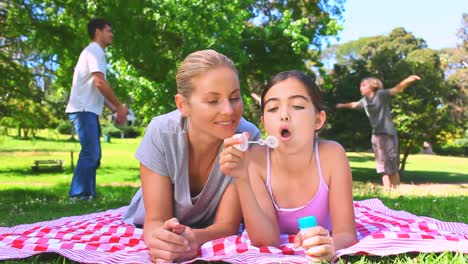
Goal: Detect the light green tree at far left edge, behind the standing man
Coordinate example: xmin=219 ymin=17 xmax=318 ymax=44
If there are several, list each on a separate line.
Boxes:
xmin=0 ymin=2 xmax=60 ymax=134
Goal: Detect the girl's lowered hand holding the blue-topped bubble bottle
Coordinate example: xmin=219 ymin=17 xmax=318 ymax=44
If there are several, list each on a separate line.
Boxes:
xmin=294 ymin=226 xmax=335 ymax=263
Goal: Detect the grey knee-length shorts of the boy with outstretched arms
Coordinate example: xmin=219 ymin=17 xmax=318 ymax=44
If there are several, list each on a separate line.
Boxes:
xmin=371 ymin=134 xmax=400 ymax=175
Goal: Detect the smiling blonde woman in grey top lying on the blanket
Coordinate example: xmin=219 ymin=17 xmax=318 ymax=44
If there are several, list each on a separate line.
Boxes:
xmin=124 ymin=50 xmax=260 ymax=262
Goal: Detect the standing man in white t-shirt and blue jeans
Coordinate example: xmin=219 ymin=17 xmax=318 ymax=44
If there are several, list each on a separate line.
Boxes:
xmin=65 ymin=18 xmax=128 ymax=200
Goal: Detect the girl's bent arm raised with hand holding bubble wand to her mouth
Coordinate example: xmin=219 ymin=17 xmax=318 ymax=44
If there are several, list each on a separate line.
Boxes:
xmin=220 ymin=138 xmax=280 ymax=247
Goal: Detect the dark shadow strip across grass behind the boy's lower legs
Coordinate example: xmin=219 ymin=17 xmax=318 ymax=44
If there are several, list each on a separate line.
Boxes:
xmin=352 ymin=168 xmax=468 ymax=185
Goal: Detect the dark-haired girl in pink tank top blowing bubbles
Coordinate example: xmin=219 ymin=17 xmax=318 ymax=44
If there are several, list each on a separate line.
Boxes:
xmin=220 ymin=71 xmax=356 ymax=261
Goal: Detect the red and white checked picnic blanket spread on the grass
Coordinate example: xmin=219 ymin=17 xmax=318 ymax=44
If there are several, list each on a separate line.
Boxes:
xmin=0 ymin=199 xmax=468 ymax=263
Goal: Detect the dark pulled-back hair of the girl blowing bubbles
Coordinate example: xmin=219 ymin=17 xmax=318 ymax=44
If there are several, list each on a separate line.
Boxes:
xmin=261 ymin=70 xmax=325 ymax=114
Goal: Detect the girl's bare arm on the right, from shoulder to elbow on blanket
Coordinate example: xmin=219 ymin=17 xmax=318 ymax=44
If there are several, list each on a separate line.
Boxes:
xmin=325 ymin=142 xmax=357 ymax=251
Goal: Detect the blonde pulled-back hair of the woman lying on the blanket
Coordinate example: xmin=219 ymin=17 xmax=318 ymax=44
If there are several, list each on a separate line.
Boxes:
xmin=176 ymin=49 xmax=238 ymax=98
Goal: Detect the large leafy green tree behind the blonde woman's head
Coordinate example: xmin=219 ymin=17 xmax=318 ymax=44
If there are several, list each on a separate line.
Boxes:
xmin=1 ymin=0 xmax=343 ymax=123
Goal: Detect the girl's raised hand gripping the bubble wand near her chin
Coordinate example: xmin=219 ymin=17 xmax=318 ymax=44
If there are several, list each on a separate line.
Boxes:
xmin=219 ymin=132 xmax=249 ymax=179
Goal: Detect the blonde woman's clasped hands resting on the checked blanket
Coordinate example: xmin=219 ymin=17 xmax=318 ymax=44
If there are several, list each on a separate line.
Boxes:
xmin=145 ymin=218 xmax=198 ymax=263
